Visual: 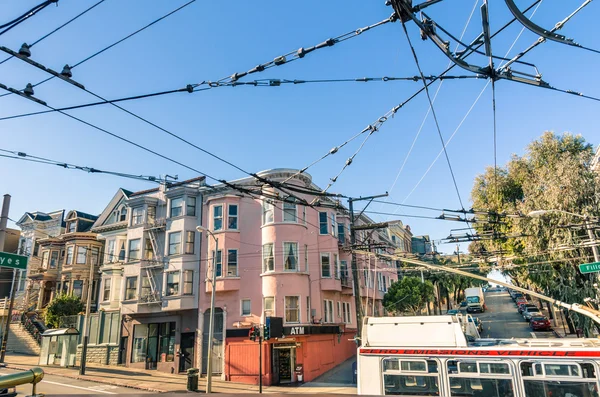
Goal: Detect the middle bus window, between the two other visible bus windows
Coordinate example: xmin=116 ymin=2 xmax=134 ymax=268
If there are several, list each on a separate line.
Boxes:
xmin=447 ymin=360 xmax=515 ymax=397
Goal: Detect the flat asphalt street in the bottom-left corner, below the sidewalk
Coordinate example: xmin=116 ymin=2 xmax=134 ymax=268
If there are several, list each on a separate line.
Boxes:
xmin=0 ymin=368 xmax=148 ymax=396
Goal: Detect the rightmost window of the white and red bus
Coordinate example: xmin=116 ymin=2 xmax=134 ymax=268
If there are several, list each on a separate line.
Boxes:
xmin=521 ymin=361 xmax=600 ymax=397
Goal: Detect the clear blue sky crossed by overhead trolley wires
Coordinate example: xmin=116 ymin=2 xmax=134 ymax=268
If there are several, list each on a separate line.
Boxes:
xmin=0 ymin=0 xmax=600 ymax=252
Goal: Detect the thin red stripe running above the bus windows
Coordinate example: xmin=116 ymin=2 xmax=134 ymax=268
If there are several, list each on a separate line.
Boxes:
xmin=360 ymin=349 xmax=600 ymax=357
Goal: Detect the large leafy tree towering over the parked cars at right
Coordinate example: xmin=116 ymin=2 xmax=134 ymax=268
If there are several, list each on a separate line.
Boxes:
xmin=469 ymin=132 xmax=600 ymax=331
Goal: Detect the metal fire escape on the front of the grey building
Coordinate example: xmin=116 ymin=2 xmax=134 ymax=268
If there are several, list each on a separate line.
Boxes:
xmin=138 ymin=207 xmax=167 ymax=304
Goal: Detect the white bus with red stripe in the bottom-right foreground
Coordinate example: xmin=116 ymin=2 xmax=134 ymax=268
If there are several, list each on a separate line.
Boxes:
xmin=357 ymin=316 xmax=600 ymax=397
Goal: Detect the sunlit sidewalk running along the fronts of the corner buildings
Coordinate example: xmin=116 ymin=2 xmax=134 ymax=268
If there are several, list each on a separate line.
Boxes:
xmin=4 ymin=354 xmax=356 ymax=394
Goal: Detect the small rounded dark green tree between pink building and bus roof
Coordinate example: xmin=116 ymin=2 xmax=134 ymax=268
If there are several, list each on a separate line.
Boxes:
xmin=383 ymin=277 xmax=433 ymax=315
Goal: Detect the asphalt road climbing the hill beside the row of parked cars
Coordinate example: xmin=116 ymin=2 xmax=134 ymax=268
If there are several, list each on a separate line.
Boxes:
xmin=474 ymin=291 xmax=554 ymax=338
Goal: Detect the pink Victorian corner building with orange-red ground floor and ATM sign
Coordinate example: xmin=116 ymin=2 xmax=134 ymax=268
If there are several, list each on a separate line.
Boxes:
xmin=198 ymin=169 xmax=397 ymax=385
